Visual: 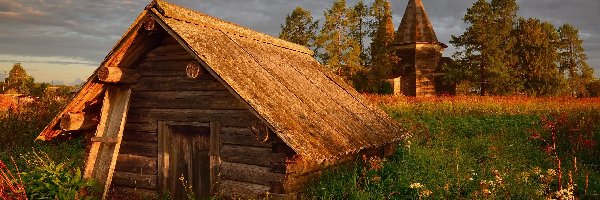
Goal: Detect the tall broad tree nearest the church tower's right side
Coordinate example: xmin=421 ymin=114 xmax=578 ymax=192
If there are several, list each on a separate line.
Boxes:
xmin=449 ymin=0 xmax=522 ymax=95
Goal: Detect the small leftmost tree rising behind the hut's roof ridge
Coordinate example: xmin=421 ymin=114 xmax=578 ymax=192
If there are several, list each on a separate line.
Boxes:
xmin=279 ymin=6 xmax=319 ymax=48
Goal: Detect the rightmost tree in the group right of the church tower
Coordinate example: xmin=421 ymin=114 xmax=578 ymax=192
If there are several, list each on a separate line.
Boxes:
xmin=558 ymin=24 xmax=594 ymax=97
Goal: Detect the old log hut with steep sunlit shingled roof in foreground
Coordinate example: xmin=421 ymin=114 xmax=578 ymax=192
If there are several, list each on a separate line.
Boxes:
xmin=38 ymin=1 xmax=403 ymax=198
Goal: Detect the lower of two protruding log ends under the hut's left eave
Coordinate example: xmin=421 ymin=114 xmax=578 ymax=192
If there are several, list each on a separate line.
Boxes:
xmin=60 ymin=112 xmax=99 ymax=131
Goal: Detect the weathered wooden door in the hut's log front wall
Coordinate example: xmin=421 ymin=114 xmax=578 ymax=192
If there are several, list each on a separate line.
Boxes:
xmin=159 ymin=125 xmax=211 ymax=199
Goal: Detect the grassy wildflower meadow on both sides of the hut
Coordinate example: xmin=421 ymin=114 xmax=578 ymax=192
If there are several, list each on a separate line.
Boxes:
xmin=0 ymin=95 xmax=600 ymax=199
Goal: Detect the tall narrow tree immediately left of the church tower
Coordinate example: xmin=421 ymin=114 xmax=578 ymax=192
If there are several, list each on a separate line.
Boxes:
xmin=369 ymin=0 xmax=398 ymax=88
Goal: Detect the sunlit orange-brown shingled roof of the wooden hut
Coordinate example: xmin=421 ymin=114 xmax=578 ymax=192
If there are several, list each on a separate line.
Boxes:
xmin=39 ymin=0 xmax=404 ymax=161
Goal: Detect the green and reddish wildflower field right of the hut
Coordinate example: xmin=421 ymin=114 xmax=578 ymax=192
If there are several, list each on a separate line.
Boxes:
xmin=307 ymin=95 xmax=600 ymax=199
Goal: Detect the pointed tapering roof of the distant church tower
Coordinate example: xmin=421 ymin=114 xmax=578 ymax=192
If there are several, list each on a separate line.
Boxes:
xmin=395 ymin=0 xmax=438 ymax=44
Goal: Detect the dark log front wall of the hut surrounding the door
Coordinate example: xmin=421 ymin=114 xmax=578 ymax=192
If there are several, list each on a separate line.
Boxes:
xmin=111 ymin=37 xmax=289 ymax=198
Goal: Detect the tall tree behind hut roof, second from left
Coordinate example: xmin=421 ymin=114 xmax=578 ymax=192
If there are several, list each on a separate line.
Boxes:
xmin=317 ymin=0 xmax=363 ymax=80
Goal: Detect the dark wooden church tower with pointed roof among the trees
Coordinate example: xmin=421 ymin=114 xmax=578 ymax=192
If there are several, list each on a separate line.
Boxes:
xmin=393 ymin=0 xmax=448 ymax=96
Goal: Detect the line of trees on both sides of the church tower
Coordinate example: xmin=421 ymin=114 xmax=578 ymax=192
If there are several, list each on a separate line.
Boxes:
xmin=279 ymin=0 xmax=600 ymax=97
